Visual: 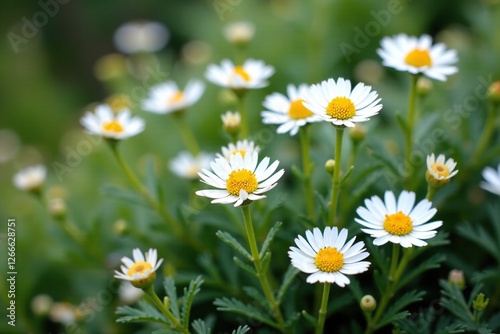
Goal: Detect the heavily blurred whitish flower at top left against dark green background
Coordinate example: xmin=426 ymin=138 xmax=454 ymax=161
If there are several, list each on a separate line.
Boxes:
xmin=113 ymin=21 xmax=170 ymax=54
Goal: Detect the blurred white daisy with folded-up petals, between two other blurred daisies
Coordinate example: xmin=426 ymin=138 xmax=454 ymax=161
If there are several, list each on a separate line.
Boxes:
xmin=142 ymin=80 xmax=205 ymax=114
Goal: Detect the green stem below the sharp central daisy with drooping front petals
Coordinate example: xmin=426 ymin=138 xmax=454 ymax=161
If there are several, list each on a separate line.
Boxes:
xmin=241 ymin=205 xmax=285 ymax=332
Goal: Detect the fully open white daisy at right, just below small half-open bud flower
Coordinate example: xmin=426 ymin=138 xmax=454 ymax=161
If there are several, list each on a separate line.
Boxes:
xmin=355 ymin=190 xmax=443 ymax=248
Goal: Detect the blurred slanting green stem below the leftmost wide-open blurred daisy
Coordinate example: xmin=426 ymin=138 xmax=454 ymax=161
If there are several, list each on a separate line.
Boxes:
xmin=110 ymin=142 xmax=184 ymax=236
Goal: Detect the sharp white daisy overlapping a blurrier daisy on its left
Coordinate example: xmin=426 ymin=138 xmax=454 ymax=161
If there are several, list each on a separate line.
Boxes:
xmin=304 ymin=78 xmax=382 ymax=127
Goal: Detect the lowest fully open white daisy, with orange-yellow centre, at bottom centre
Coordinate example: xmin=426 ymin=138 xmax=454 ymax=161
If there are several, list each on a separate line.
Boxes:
xmin=288 ymin=227 xmax=370 ymax=287
